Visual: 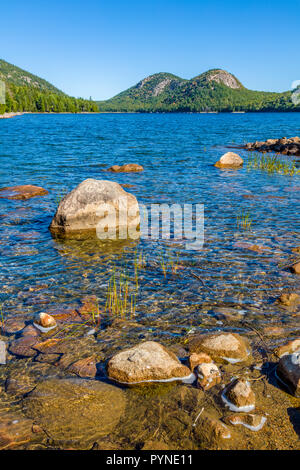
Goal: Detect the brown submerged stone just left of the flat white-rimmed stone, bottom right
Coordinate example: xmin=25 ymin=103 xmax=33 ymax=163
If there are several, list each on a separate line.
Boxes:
xmin=194 ymin=413 xmax=231 ymax=443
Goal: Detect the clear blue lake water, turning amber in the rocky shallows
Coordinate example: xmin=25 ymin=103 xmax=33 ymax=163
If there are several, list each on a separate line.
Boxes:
xmin=0 ymin=113 xmax=300 ymax=449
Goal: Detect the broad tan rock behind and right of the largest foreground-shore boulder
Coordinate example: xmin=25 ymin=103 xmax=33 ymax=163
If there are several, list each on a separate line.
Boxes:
xmin=189 ymin=333 xmax=249 ymax=364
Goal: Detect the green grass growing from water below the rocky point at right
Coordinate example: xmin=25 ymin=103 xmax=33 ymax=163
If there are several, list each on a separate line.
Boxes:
xmin=247 ymin=153 xmax=300 ymax=176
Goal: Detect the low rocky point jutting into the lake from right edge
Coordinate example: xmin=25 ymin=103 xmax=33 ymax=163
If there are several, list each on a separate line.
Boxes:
xmin=244 ymin=137 xmax=300 ymax=156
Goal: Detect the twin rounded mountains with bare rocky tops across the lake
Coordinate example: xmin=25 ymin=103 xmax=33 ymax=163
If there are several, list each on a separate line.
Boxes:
xmin=98 ymin=69 xmax=300 ymax=112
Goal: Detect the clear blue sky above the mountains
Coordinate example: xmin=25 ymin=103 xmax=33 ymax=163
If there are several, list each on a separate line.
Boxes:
xmin=0 ymin=0 xmax=300 ymax=99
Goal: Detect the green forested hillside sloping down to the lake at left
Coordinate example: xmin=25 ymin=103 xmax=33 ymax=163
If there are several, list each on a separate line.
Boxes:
xmin=0 ymin=59 xmax=99 ymax=114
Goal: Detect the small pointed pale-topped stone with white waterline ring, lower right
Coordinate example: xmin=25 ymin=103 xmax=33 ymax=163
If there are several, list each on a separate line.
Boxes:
xmin=222 ymin=380 xmax=255 ymax=412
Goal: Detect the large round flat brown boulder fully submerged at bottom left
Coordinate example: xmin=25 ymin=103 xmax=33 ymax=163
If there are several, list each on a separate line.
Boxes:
xmin=23 ymin=378 xmax=126 ymax=448
